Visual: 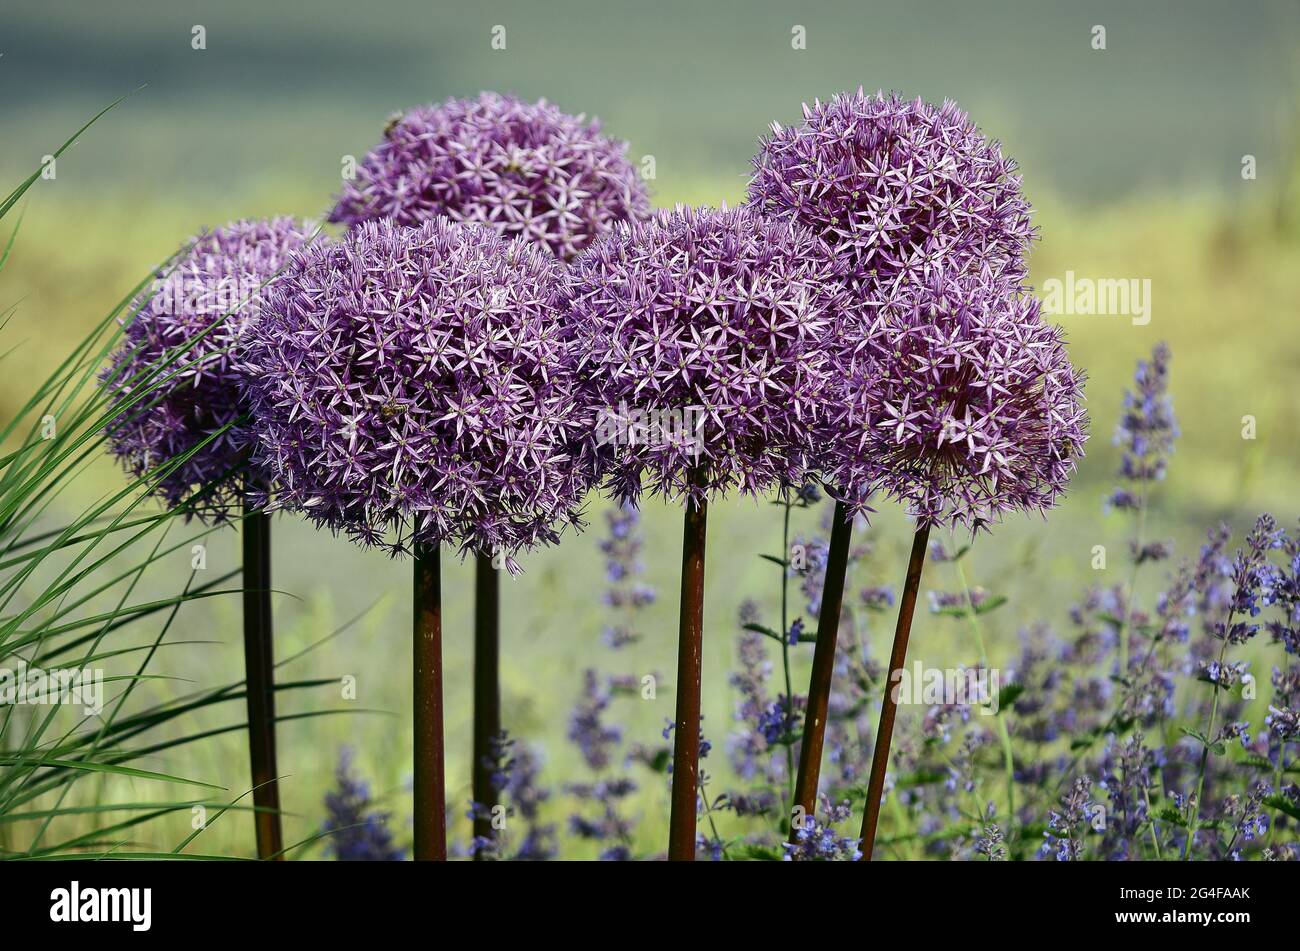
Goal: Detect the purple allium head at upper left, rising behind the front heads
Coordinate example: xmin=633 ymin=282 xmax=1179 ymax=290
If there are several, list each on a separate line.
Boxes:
xmin=330 ymin=92 xmax=650 ymax=261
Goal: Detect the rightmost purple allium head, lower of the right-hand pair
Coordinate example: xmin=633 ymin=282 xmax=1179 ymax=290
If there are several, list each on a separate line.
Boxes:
xmin=823 ymin=274 xmax=1087 ymax=527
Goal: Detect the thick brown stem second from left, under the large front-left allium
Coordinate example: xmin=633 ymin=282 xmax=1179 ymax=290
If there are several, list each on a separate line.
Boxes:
xmin=412 ymin=544 xmax=447 ymax=861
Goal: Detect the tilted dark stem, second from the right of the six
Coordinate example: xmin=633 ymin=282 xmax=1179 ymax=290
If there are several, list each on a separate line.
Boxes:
xmin=790 ymin=501 xmax=853 ymax=842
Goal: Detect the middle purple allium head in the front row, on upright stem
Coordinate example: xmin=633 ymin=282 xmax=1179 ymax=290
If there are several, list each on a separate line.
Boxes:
xmin=569 ymin=208 xmax=845 ymax=501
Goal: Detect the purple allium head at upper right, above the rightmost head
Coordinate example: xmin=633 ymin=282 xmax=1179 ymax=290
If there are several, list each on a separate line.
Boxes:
xmin=749 ymin=88 xmax=1035 ymax=300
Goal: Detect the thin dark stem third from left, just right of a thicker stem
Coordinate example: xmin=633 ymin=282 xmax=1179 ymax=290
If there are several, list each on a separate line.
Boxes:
xmin=472 ymin=552 xmax=501 ymax=859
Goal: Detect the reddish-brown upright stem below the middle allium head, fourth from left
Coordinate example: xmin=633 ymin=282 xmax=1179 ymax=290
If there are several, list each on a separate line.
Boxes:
xmin=668 ymin=485 xmax=709 ymax=861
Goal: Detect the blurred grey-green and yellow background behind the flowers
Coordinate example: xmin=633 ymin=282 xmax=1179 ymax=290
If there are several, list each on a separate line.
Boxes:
xmin=0 ymin=0 xmax=1300 ymax=855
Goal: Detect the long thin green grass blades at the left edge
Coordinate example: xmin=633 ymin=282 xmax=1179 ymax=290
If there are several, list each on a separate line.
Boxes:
xmin=0 ymin=104 xmax=320 ymax=859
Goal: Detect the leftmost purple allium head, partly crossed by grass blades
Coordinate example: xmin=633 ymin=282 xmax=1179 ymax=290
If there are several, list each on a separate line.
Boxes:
xmin=103 ymin=218 xmax=317 ymax=520
